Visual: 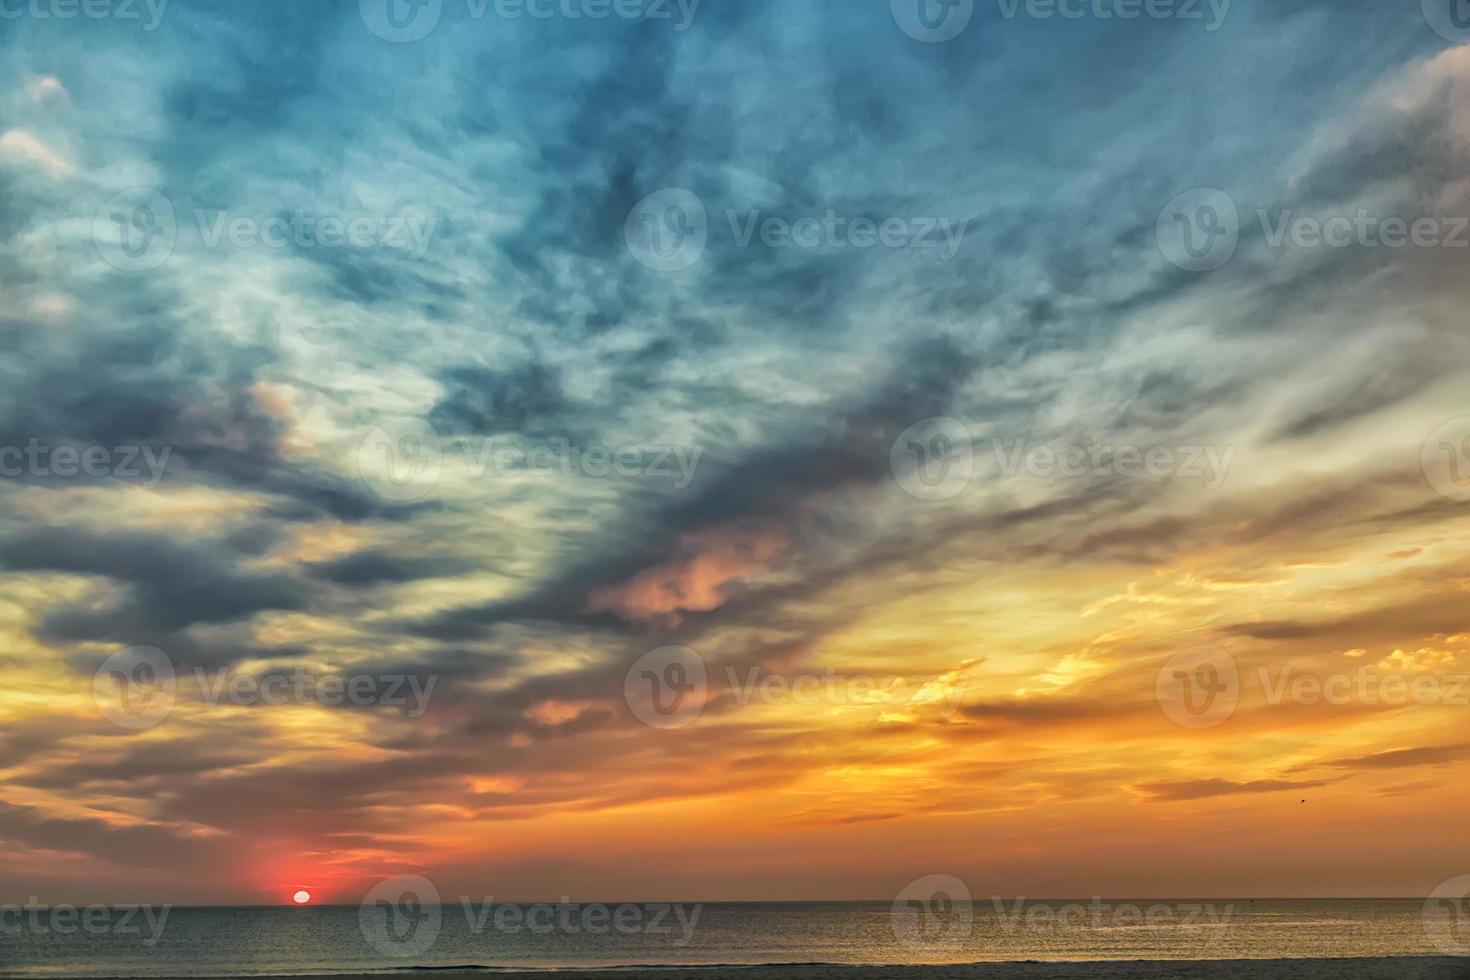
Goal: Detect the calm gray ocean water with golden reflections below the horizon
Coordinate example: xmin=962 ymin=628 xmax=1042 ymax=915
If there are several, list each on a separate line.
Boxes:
xmin=0 ymin=899 xmax=1445 ymax=977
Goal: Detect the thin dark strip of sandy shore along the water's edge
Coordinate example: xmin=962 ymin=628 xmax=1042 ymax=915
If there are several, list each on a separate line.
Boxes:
xmin=149 ymin=956 xmax=1470 ymax=980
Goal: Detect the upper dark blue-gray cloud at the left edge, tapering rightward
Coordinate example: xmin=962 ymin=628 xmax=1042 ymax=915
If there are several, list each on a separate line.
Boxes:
xmin=0 ymin=278 xmax=415 ymax=520
